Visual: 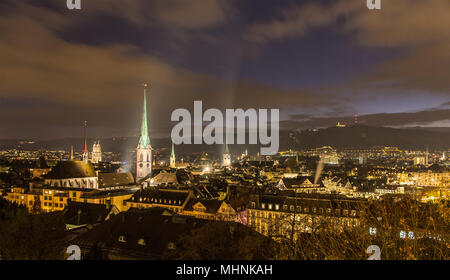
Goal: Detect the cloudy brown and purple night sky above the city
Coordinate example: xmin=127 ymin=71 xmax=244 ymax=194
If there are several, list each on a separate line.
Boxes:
xmin=0 ymin=0 xmax=450 ymax=139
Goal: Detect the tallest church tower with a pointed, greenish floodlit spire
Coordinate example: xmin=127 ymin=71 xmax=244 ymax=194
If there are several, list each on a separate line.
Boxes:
xmin=136 ymin=84 xmax=152 ymax=181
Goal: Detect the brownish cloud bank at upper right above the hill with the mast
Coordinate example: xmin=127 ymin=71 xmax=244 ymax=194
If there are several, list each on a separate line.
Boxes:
xmin=246 ymin=0 xmax=450 ymax=96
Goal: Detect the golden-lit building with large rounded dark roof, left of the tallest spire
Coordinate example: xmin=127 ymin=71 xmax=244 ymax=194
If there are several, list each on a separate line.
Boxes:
xmin=6 ymin=161 xmax=137 ymax=212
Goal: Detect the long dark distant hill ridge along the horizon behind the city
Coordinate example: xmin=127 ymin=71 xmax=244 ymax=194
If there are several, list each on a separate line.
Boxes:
xmin=0 ymin=125 xmax=450 ymax=154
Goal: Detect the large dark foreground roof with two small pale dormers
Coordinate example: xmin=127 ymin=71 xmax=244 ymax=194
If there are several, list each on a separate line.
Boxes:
xmin=72 ymin=208 xmax=206 ymax=259
